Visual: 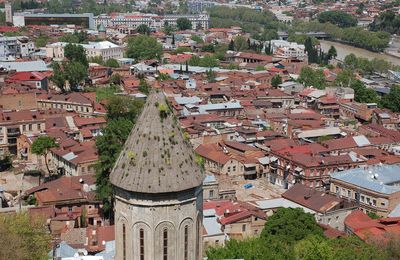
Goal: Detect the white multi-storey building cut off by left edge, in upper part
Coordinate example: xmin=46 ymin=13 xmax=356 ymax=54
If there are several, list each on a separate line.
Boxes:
xmin=0 ymin=36 xmax=35 ymax=60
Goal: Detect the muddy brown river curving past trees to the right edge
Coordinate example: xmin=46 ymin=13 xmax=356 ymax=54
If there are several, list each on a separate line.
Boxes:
xmin=320 ymin=40 xmax=400 ymax=66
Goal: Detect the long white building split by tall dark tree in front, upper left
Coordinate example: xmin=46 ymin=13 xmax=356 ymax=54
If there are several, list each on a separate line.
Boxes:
xmin=46 ymin=41 xmax=124 ymax=61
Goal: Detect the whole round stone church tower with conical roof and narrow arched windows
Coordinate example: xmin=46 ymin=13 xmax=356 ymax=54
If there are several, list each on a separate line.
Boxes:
xmin=110 ymin=92 xmax=203 ymax=260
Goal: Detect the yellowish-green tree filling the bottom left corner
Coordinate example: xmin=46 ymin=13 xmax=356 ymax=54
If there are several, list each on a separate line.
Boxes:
xmin=0 ymin=213 xmax=51 ymax=260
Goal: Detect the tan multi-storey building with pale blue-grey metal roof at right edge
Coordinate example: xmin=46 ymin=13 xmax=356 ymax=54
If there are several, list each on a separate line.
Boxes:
xmin=330 ymin=165 xmax=400 ymax=217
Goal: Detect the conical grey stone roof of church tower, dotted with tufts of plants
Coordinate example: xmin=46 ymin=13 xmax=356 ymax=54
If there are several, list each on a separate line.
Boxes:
xmin=110 ymin=92 xmax=203 ymax=193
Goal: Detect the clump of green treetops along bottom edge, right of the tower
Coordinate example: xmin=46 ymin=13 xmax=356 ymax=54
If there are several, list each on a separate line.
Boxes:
xmin=206 ymin=208 xmax=388 ymax=260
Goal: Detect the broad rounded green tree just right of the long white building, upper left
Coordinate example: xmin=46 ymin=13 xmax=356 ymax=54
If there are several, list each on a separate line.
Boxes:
xmin=126 ymin=35 xmax=162 ymax=60
